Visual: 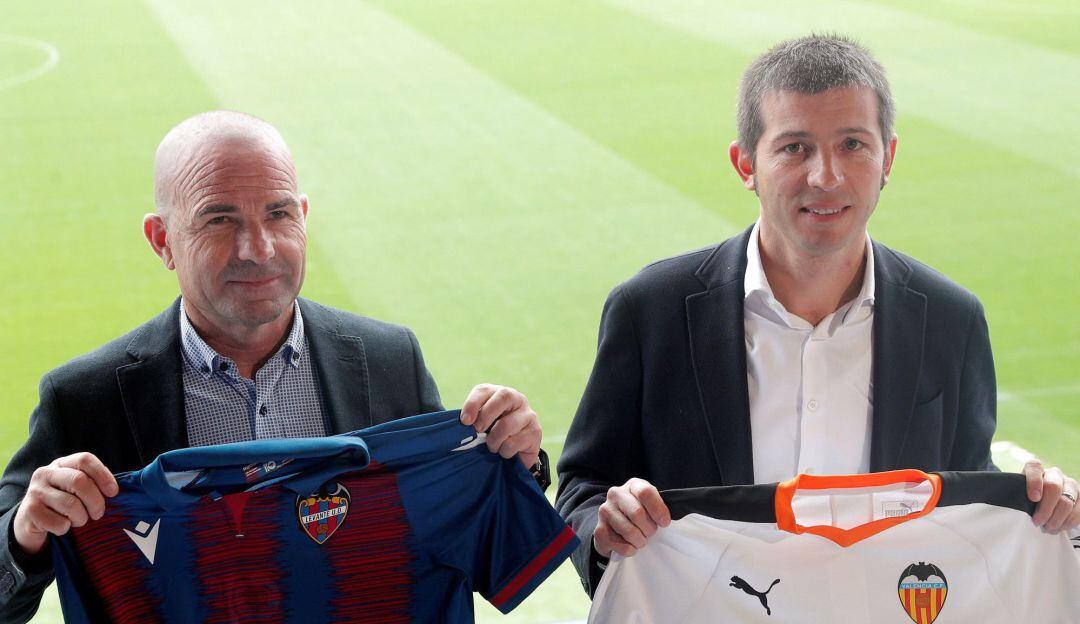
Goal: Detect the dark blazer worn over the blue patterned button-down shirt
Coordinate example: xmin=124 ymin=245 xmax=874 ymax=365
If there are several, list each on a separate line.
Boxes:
xmin=0 ymin=299 xmax=443 ymax=622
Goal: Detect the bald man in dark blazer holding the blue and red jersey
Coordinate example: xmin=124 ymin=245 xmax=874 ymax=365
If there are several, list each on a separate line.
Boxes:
xmin=0 ymin=111 xmax=544 ymax=622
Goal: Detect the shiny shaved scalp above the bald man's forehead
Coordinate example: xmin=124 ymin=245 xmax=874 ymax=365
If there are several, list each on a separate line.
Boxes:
xmin=153 ymin=110 xmax=296 ymax=218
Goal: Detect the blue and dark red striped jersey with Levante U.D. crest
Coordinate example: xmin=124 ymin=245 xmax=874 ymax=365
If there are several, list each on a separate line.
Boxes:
xmin=53 ymin=411 xmax=578 ymax=623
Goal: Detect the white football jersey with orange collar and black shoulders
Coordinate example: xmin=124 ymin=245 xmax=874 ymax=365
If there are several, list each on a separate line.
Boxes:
xmin=589 ymin=471 xmax=1080 ymax=624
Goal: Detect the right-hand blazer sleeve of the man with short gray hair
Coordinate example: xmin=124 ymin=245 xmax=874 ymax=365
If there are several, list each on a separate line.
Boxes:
xmin=948 ymin=296 xmax=998 ymax=471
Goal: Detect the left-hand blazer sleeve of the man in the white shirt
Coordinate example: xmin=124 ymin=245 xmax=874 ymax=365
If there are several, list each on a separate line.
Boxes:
xmin=555 ymin=286 xmax=647 ymax=596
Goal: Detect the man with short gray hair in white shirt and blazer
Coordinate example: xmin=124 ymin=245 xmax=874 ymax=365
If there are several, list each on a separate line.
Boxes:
xmin=556 ymin=36 xmax=1080 ymax=594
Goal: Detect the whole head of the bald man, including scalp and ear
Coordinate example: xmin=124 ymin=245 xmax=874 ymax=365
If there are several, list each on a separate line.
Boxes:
xmin=143 ymin=111 xmax=308 ymax=345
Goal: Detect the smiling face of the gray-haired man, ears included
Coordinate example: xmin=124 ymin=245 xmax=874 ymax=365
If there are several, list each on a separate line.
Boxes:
xmin=731 ymin=87 xmax=896 ymax=259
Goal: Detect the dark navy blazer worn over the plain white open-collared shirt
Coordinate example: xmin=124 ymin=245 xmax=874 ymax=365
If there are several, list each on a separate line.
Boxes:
xmin=555 ymin=230 xmax=997 ymax=595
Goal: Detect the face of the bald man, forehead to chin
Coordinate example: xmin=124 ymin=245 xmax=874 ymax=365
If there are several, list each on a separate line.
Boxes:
xmin=162 ymin=138 xmax=308 ymax=330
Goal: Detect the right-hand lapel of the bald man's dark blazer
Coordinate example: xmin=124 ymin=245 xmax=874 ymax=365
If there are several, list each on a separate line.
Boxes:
xmin=299 ymin=299 xmax=373 ymax=434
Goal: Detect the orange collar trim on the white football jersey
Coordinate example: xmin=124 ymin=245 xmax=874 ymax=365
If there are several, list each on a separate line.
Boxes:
xmin=775 ymin=470 xmax=942 ymax=547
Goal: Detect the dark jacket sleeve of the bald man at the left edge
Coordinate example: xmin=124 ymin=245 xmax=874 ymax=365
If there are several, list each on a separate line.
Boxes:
xmin=0 ymin=375 xmax=63 ymax=622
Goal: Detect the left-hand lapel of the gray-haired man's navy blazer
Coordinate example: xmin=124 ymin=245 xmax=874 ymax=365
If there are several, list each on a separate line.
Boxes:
xmin=686 ymin=229 xmax=754 ymax=486
